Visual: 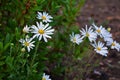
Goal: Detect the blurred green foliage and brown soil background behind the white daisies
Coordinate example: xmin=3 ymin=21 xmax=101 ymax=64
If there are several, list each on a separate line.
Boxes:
xmin=0 ymin=0 xmax=120 ymax=80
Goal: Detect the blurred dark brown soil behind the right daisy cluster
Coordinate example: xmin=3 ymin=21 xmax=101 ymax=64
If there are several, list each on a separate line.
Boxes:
xmin=78 ymin=0 xmax=120 ymax=80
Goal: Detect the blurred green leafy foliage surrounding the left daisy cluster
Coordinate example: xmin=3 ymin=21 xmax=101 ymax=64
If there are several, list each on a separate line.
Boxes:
xmin=0 ymin=0 xmax=86 ymax=80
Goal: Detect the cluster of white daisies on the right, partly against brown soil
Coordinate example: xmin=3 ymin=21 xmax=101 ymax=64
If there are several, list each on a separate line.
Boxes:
xmin=70 ymin=23 xmax=120 ymax=56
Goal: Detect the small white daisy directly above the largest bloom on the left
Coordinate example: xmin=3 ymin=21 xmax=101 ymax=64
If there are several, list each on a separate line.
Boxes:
xmin=37 ymin=12 xmax=53 ymax=23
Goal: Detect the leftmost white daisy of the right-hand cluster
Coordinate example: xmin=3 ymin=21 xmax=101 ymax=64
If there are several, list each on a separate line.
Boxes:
xmin=70 ymin=32 xmax=83 ymax=45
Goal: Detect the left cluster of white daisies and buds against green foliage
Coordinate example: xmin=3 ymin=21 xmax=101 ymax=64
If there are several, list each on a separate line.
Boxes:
xmin=19 ymin=12 xmax=54 ymax=52
